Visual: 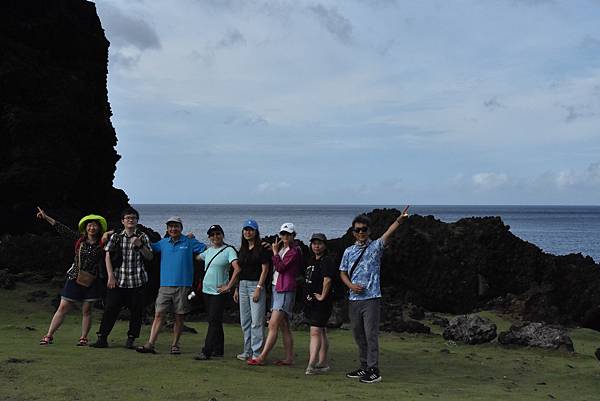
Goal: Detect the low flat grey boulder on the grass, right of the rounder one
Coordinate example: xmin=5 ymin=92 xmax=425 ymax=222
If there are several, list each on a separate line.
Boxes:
xmin=498 ymin=322 xmax=575 ymax=352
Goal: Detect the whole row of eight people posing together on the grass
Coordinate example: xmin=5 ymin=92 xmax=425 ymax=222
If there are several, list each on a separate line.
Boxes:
xmin=37 ymin=206 xmax=408 ymax=383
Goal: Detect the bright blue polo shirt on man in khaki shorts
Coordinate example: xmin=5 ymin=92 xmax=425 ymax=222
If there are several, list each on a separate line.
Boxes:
xmin=151 ymin=235 xmax=206 ymax=287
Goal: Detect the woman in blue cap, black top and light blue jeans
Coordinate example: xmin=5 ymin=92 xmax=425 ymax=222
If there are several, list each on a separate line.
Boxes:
xmin=233 ymin=219 xmax=271 ymax=361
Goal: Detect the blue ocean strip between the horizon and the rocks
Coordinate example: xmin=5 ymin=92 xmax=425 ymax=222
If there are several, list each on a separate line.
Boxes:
xmin=134 ymin=204 xmax=600 ymax=262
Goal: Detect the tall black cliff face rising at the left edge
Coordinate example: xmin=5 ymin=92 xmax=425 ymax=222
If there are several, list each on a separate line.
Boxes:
xmin=0 ymin=0 xmax=128 ymax=234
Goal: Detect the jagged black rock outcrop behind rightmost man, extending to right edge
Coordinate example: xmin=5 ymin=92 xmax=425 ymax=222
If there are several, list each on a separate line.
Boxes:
xmin=329 ymin=209 xmax=600 ymax=329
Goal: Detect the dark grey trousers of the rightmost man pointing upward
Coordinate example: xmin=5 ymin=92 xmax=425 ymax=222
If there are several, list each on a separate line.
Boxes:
xmin=349 ymin=298 xmax=380 ymax=369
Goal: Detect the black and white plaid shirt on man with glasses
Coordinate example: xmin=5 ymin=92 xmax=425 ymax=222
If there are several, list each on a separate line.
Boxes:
xmin=104 ymin=229 xmax=150 ymax=288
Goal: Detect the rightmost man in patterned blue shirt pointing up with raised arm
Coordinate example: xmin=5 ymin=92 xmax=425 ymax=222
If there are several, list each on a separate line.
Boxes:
xmin=340 ymin=206 xmax=408 ymax=383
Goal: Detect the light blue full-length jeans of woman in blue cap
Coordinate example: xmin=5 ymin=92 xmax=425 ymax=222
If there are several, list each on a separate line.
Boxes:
xmin=238 ymin=280 xmax=267 ymax=357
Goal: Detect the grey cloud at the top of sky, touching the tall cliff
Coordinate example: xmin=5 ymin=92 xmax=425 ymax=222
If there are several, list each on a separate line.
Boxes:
xmin=98 ymin=3 xmax=161 ymax=50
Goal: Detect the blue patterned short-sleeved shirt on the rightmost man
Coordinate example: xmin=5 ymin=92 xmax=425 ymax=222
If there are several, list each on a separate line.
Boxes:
xmin=340 ymin=238 xmax=384 ymax=301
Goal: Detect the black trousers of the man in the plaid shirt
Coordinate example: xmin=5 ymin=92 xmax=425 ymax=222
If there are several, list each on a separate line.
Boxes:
xmin=98 ymin=286 xmax=145 ymax=338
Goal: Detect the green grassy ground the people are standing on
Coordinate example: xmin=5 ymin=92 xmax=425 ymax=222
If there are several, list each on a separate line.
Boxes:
xmin=0 ymin=284 xmax=600 ymax=401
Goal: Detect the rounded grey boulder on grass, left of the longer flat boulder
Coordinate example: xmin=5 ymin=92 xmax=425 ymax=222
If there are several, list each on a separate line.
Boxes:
xmin=442 ymin=315 xmax=496 ymax=344
